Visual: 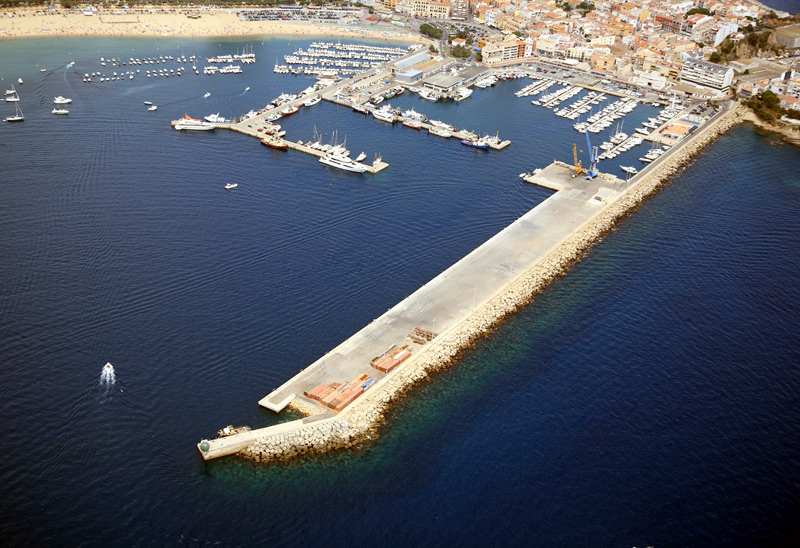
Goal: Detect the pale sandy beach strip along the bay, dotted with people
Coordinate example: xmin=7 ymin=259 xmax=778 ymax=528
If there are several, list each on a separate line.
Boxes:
xmin=0 ymin=9 xmax=424 ymax=42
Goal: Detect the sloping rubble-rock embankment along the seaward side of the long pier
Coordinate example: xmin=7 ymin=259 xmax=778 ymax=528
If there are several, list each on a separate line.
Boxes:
xmin=239 ymin=103 xmax=746 ymax=462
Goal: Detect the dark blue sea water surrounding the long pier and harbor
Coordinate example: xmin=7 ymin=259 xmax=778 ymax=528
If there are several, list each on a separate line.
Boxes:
xmin=0 ymin=37 xmax=800 ymax=547
